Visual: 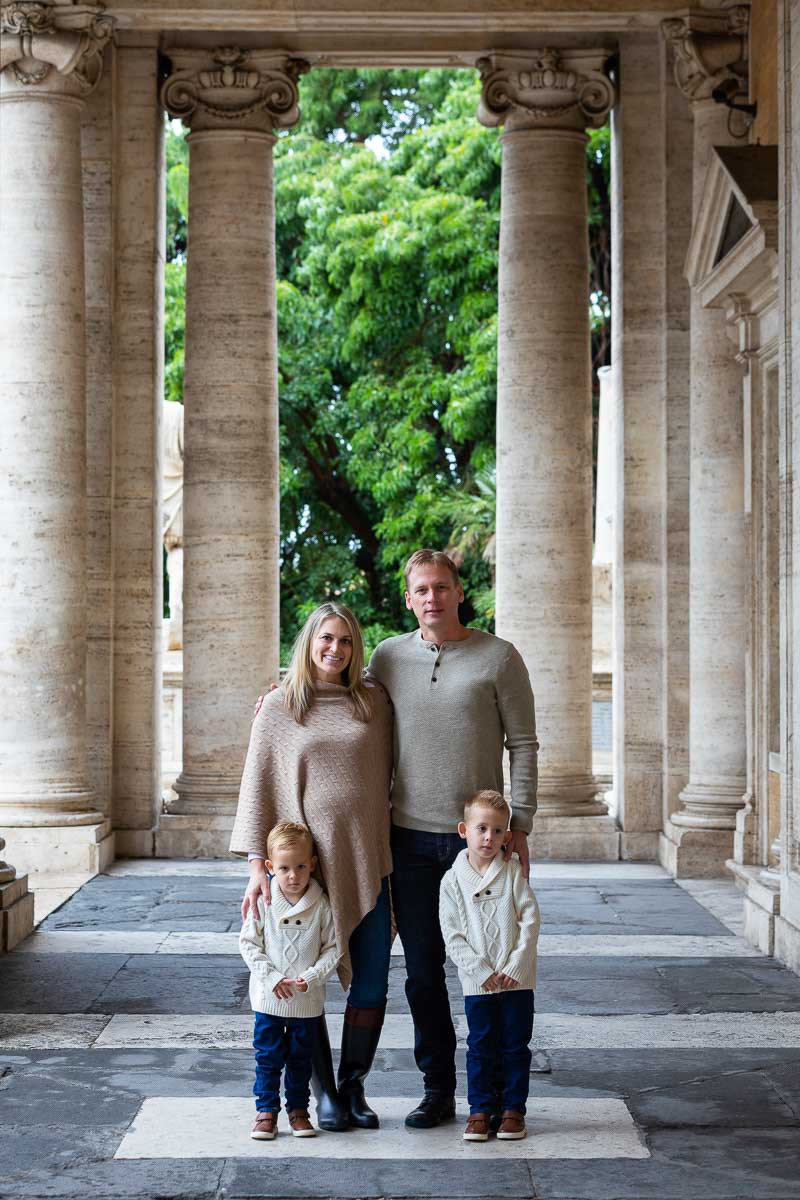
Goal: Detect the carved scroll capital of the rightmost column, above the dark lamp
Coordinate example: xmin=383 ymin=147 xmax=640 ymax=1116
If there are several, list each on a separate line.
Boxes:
xmin=661 ymin=5 xmax=750 ymax=101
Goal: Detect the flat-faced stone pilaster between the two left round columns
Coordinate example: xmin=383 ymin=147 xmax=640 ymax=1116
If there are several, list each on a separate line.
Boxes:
xmin=113 ymin=44 xmax=166 ymax=858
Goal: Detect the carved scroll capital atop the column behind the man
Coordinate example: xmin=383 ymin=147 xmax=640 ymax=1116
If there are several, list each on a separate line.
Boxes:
xmin=476 ymin=49 xmax=614 ymax=130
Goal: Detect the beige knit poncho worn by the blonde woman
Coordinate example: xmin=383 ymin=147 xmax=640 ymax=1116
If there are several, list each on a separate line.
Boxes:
xmin=230 ymin=683 xmax=392 ymax=988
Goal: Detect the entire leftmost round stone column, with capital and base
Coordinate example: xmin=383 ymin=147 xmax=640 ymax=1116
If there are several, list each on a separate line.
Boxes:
xmin=0 ymin=2 xmax=112 ymax=871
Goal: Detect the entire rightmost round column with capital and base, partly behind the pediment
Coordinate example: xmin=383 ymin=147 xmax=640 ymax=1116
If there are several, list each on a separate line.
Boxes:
xmin=661 ymin=6 xmax=748 ymax=877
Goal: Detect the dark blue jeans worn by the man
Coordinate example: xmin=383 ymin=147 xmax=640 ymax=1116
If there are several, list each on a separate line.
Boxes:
xmin=392 ymin=826 xmax=464 ymax=1096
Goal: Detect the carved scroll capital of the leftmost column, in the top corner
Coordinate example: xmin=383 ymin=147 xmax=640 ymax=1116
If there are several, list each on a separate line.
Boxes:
xmin=0 ymin=0 xmax=114 ymax=97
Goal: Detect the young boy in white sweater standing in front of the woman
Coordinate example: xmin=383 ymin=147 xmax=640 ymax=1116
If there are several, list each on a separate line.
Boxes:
xmin=239 ymin=821 xmax=337 ymax=1141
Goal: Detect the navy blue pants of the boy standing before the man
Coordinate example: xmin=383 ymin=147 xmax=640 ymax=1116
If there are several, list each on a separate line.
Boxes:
xmin=464 ymin=988 xmax=534 ymax=1112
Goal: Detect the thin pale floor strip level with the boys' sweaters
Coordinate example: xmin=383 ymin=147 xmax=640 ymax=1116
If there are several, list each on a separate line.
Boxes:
xmin=13 ymin=929 xmax=763 ymax=959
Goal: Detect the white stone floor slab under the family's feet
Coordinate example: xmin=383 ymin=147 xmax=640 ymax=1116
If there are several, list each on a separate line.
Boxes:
xmin=114 ymin=1096 xmax=650 ymax=1163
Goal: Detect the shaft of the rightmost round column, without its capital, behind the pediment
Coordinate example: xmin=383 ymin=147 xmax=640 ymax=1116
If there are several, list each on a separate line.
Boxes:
xmin=672 ymin=100 xmax=747 ymax=830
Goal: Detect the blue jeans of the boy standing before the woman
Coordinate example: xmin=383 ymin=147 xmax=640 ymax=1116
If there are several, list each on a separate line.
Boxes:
xmin=253 ymin=1013 xmax=317 ymax=1112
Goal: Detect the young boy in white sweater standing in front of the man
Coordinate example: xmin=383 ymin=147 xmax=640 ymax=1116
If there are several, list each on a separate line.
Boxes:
xmin=439 ymin=791 xmax=540 ymax=1141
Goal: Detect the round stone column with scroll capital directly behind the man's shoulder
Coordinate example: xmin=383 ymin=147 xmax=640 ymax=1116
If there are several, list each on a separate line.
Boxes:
xmin=479 ymin=49 xmax=618 ymax=858
